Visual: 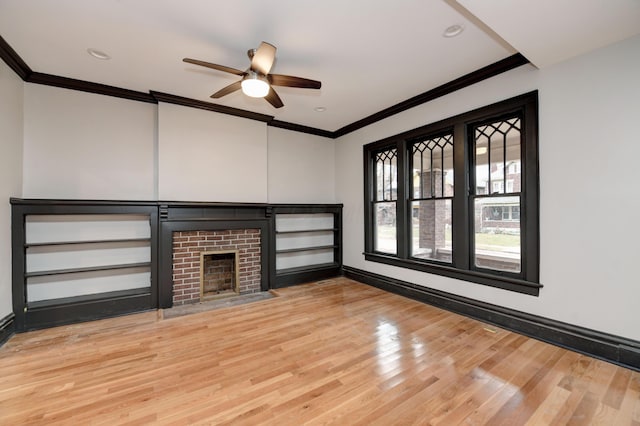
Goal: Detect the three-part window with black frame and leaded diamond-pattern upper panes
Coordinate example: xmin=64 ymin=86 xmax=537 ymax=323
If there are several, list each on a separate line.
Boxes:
xmin=364 ymin=92 xmax=542 ymax=295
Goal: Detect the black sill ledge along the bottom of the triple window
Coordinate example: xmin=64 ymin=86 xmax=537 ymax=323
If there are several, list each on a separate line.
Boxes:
xmin=363 ymin=253 xmax=543 ymax=296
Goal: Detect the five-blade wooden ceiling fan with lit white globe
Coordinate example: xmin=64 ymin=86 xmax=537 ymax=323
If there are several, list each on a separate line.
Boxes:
xmin=183 ymin=41 xmax=322 ymax=108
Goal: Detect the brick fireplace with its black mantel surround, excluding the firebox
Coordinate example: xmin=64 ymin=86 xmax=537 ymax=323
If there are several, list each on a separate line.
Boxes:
xmin=157 ymin=203 xmax=274 ymax=308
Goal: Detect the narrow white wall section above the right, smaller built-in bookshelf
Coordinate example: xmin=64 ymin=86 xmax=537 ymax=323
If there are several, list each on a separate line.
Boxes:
xmin=268 ymin=127 xmax=336 ymax=203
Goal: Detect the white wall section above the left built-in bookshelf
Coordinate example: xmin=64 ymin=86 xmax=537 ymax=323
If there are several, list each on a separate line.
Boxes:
xmin=23 ymin=84 xmax=156 ymax=200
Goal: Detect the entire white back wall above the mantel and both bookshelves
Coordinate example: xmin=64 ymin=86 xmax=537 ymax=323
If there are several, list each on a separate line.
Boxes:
xmin=20 ymin=85 xmax=335 ymax=203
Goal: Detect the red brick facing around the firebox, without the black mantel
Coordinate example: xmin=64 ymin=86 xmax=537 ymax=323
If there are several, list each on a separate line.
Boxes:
xmin=172 ymin=228 xmax=262 ymax=306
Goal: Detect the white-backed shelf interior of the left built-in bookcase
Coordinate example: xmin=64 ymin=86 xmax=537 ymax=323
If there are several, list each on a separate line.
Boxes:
xmin=25 ymin=214 xmax=151 ymax=306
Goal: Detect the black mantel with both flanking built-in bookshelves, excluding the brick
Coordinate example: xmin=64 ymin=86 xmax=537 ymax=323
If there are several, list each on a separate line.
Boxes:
xmin=11 ymin=198 xmax=342 ymax=332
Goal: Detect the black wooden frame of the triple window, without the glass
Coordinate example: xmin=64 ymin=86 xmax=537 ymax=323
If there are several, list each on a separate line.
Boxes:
xmin=363 ymin=91 xmax=542 ymax=296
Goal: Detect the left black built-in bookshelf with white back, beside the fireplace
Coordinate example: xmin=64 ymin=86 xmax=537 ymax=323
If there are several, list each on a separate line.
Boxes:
xmin=13 ymin=203 xmax=157 ymax=330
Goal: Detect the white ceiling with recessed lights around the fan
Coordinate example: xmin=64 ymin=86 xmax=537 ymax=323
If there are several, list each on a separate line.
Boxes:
xmin=0 ymin=0 xmax=640 ymax=131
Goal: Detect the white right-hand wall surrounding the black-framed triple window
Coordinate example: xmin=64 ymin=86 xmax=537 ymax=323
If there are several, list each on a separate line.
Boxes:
xmin=336 ymin=33 xmax=640 ymax=340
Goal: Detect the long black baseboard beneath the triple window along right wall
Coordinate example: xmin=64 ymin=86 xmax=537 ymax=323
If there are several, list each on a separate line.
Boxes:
xmin=343 ymin=266 xmax=640 ymax=371
